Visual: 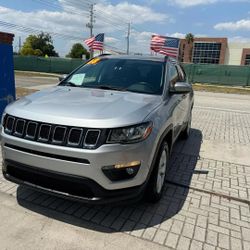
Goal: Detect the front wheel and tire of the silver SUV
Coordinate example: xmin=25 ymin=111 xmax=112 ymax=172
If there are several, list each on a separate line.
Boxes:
xmin=145 ymin=142 xmax=169 ymax=203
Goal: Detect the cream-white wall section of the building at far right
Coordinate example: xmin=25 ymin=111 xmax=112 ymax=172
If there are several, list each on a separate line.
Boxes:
xmin=225 ymin=43 xmax=250 ymax=65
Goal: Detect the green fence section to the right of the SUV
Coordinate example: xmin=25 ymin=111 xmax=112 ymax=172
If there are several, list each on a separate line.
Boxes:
xmin=183 ymin=64 xmax=250 ymax=87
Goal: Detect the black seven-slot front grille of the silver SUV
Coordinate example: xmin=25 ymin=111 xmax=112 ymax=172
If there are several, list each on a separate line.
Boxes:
xmin=3 ymin=115 xmax=104 ymax=148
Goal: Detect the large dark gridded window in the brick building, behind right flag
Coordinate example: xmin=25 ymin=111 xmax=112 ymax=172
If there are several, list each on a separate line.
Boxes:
xmin=193 ymin=42 xmax=221 ymax=64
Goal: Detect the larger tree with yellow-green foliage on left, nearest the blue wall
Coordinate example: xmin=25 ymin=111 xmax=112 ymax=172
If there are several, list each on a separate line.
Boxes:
xmin=21 ymin=32 xmax=58 ymax=57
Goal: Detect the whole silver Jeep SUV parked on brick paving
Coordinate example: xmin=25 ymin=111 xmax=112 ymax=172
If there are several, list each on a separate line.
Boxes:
xmin=1 ymin=55 xmax=193 ymax=203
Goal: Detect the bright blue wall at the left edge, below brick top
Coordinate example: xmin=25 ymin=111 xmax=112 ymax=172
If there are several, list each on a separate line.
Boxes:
xmin=0 ymin=41 xmax=16 ymax=117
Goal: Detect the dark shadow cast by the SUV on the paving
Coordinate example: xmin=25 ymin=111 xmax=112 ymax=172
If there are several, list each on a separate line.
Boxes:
xmin=17 ymin=129 xmax=203 ymax=232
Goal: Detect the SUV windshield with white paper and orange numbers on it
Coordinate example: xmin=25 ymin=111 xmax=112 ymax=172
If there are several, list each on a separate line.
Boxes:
xmin=60 ymin=58 xmax=163 ymax=95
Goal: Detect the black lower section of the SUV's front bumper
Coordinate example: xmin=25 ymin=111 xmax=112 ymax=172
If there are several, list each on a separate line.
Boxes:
xmin=3 ymin=160 xmax=146 ymax=204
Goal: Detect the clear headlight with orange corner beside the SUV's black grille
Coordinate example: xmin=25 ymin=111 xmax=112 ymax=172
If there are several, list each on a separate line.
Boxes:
xmin=107 ymin=122 xmax=153 ymax=143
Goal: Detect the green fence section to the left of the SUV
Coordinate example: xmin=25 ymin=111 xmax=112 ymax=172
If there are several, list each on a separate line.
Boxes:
xmin=14 ymin=56 xmax=83 ymax=74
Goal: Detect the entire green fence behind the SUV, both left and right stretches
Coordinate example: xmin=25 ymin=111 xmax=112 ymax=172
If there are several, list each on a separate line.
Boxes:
xmin=14 ymin=56 xmax=250 ymax=86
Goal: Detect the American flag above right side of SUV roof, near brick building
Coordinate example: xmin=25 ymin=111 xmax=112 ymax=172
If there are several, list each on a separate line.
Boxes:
xmin=151 ymin=36 xmax=180 ymax=58
